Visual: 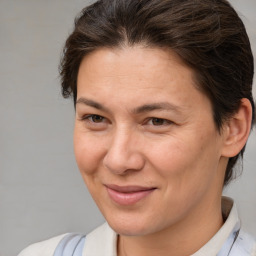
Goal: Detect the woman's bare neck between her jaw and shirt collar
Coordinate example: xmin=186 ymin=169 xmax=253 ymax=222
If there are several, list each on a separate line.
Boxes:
xmin=118 ymin=197 xmax=223 ymax=256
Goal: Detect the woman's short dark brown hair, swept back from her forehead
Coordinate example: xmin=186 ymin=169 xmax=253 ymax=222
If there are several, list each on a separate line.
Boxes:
xmin=60 ymin=0 xmax=255 ymax=185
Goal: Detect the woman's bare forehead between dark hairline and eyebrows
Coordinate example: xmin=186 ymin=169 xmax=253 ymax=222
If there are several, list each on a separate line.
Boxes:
xmin=77 ymin=46 xmax=212 ymax=113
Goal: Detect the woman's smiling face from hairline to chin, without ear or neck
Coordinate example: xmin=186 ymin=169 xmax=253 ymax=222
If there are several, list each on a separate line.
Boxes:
xmin=74 ymin=46 xmax=226 ymax=235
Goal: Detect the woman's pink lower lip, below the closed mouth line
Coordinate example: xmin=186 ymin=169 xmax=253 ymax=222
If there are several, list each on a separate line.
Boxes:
xmin=107 ymin=188 xmax=155 ymax=205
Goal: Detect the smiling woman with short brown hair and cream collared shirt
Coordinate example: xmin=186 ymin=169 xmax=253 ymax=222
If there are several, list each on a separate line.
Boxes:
xmin=20 ymin=0 xmax=256 ymax=256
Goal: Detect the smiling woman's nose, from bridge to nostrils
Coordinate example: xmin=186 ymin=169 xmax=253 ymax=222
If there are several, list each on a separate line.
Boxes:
xmin=103 ymin=131 xmax=145 ymax=175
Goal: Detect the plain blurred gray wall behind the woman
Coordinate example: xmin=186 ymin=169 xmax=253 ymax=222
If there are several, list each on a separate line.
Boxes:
xmin=0 ymin=0 xmax=256 ymax=256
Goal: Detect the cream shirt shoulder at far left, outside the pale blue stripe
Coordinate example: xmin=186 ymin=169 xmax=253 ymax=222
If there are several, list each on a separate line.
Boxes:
xmin=18 ymin=234 xmax=66 ymax=256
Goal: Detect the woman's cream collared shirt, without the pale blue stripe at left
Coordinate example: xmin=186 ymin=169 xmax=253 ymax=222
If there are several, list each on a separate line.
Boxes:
xmin=18 ymin=197 xmax=256 ymax=256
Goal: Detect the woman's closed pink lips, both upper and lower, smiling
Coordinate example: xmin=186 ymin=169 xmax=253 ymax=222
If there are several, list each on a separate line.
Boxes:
xmin=106 ymin=184 xmax=156 ymax=205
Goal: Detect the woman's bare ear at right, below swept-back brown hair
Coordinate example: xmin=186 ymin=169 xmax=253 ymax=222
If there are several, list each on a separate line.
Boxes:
xmin=222 ymin=98 xmax=252 ymax=157
